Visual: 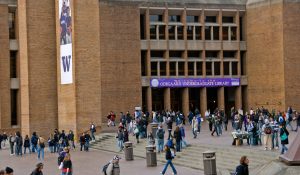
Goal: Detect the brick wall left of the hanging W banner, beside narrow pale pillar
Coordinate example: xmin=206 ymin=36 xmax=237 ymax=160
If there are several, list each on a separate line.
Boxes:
xmin=26 ymin=0 xmax=58 ymax=137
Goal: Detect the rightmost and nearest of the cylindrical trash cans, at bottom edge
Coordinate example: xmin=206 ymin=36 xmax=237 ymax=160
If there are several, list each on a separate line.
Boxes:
xmin=203 ymin=151 xmax=217 ymax=175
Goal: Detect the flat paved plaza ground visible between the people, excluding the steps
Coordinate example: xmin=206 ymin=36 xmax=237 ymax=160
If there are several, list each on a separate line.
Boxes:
xmin=0 ymin=120 xmax=296 ymax=175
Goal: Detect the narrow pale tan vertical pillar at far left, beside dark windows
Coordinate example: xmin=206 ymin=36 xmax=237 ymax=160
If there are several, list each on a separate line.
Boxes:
xmin=17 ymin=1 xmax=31 ymax=136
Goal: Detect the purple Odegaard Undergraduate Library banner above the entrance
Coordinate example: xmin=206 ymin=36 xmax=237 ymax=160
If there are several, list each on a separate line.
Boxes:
xmin=150 ymin=78 xmax=240 ymax=88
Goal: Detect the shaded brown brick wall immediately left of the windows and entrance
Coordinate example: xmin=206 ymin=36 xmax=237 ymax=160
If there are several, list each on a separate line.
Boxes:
xmin=100 ymin=2 xmax=142 ymax=122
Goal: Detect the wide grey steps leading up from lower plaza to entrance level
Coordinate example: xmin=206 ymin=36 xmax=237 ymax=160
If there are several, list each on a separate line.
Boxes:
xmin=91 ymin=133 xmax=279 ymax=174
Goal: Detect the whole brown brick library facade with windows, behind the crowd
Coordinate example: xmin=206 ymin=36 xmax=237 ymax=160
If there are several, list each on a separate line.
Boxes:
xmin=0 ymin=0 xmax=300 ymax=135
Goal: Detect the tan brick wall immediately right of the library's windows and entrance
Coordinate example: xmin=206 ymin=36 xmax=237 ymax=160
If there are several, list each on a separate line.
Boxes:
xmin=247 ymin=3 xmax=285 ymax=110
